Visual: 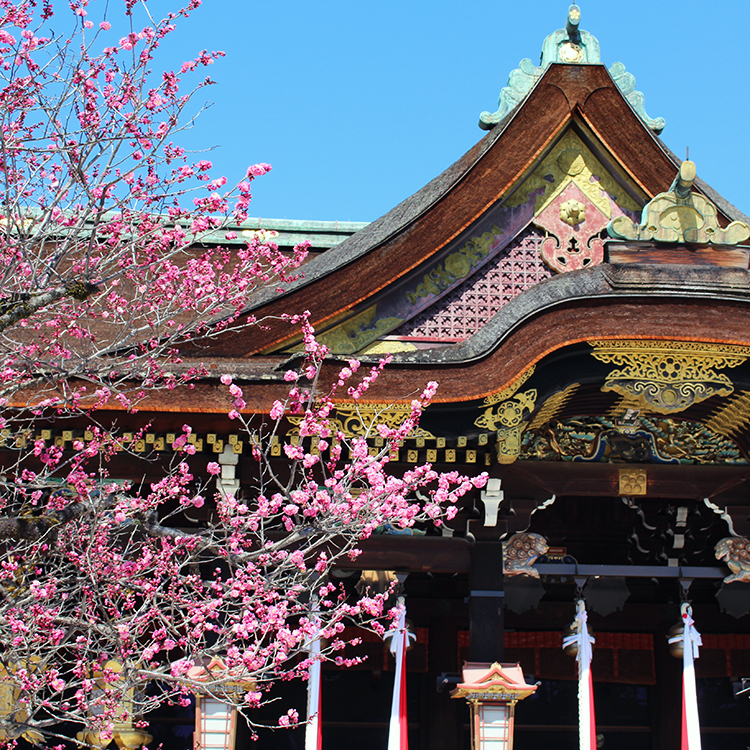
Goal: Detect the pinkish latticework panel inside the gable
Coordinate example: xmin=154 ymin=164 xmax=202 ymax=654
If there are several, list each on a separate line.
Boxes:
xmin=389 ymin=228 xmax=552 ymax=343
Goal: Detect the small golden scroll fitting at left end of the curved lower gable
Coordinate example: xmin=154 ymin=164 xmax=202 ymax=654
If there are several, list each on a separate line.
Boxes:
xmin=474 ymin=367 xmax=537 ymax=464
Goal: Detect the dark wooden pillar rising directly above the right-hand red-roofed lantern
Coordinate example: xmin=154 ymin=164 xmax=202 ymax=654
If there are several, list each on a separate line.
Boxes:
xmin=469 ymin=541 xmax=504 ymax=662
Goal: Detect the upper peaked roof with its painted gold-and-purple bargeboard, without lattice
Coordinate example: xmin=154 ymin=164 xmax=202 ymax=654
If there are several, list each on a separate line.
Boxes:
xmin=215 ymin=55 xmax=747 ymax=357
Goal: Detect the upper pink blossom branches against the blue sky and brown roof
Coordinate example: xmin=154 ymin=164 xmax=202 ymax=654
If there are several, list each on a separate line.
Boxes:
xmin=0 ymin=0 xmax=306 ymax=415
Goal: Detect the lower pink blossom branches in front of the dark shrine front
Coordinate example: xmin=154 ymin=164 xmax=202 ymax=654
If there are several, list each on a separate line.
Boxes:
xmin=0 ymin=316 xmax=486 ymax=734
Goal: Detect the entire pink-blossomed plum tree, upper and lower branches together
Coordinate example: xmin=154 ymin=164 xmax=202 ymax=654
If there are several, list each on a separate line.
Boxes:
xmin=0 ymin=0 xmax=486 ymax=744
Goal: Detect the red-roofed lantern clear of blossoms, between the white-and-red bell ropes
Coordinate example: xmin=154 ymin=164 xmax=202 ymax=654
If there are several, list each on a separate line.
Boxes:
xmin=451 ymin=662 xmax=537 ymax=750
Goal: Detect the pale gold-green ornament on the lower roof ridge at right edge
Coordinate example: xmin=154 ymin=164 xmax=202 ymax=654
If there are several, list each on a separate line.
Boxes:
xmin=607 ymin=161 xmax=750 ymax=245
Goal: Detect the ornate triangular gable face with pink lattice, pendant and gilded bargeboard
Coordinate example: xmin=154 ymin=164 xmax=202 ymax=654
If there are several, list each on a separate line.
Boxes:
xmin=320 ymin=122 xmax=648 ymax=354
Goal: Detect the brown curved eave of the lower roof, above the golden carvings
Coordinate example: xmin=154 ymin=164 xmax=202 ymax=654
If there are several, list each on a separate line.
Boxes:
xmin=92 ymin=280 xmax=750 ymax=414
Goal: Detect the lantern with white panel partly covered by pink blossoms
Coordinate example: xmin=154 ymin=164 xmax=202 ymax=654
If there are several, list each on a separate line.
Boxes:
xmin=188 ymin=657 xmax=255 ymax=750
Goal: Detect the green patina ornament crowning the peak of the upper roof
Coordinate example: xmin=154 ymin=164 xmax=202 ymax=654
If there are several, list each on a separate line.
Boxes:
xmin=479 ymin=3 xmax=666 ymax=134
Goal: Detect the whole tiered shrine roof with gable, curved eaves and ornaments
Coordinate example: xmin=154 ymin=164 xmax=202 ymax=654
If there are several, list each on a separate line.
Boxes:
xmin=32 ymin=5 xmax=750 ymax=548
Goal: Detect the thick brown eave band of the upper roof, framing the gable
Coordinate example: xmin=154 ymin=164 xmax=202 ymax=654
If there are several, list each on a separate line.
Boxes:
xmin=200 ymin=64 xmax=739 ymax=358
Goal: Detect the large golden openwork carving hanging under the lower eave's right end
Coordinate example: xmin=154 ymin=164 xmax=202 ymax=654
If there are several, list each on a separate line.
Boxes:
xmin=591 ymin=340 xmax=750 ymax=414
